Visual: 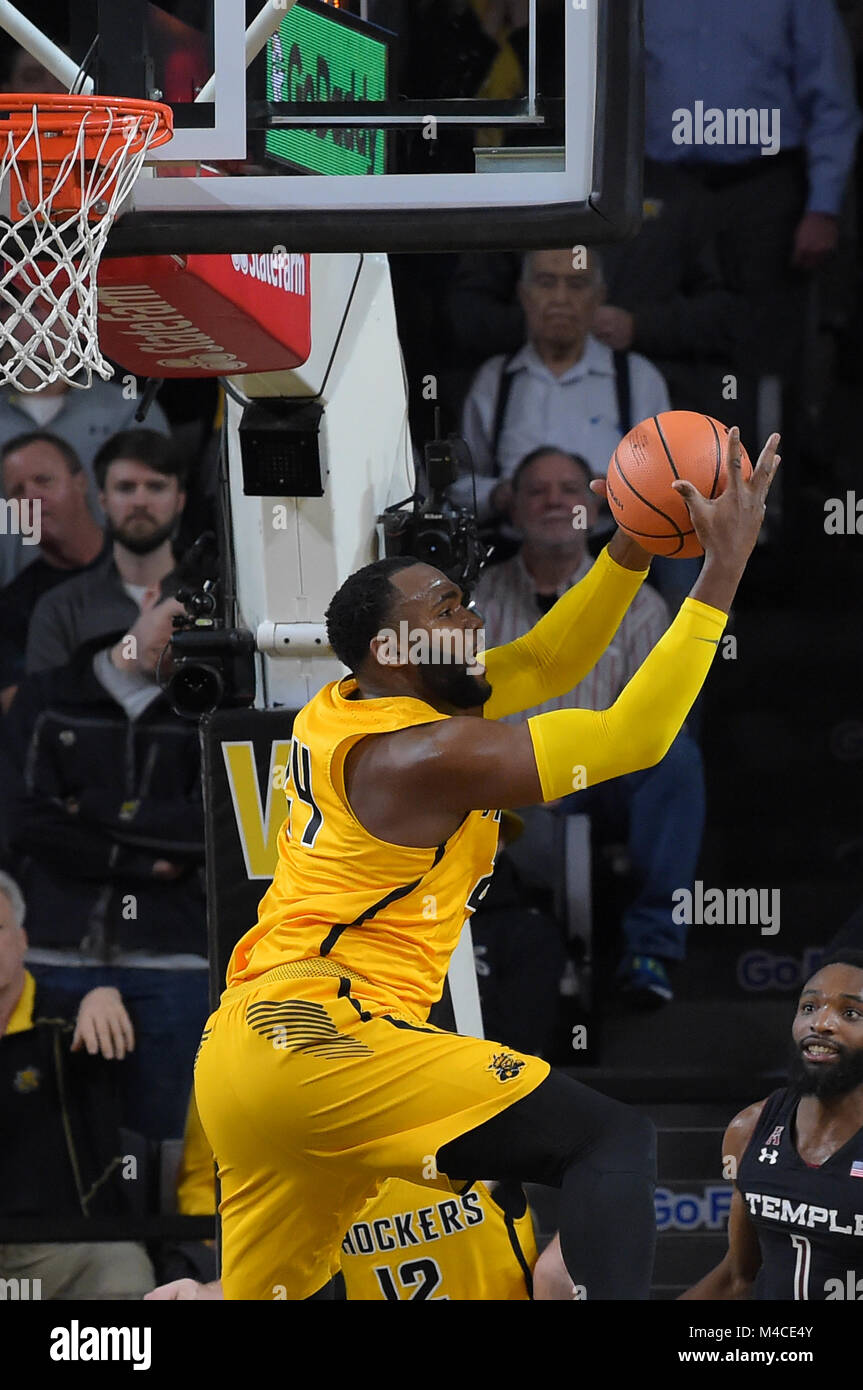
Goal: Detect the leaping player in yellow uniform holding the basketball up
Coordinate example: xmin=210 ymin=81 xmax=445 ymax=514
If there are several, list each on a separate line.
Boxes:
xmin=196 ymin=430 xmax=778 ymax=1300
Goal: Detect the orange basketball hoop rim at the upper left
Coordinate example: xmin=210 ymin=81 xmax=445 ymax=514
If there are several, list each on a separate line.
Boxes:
xmin=0 ymin=92 xmax=174 ymax=221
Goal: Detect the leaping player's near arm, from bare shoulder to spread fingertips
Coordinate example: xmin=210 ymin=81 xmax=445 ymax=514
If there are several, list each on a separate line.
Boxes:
xmin=394 ymin=430 xmax=778 ymax=811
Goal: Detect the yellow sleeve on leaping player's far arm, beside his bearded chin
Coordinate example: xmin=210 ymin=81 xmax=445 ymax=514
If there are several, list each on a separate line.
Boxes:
xmin=482 ymin=546 xmax=648 ymax=719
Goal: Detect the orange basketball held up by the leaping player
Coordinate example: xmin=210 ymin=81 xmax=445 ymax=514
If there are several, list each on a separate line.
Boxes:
xmin=607 ymin=410 xmax=752 ymax=559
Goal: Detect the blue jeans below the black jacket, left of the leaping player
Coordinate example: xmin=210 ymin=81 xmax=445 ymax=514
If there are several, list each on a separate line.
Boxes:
xmin=31 ymin=965 xmax=210 ymax=1140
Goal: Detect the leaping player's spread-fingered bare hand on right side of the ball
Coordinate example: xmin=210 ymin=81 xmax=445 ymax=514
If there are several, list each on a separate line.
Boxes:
xmin=671 ymin=425 xmax=780 ymax=573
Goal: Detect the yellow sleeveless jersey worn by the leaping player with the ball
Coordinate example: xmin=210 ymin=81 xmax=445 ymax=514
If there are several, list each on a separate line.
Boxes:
xmin=228 ymin=677 xmax=500 ymax=1020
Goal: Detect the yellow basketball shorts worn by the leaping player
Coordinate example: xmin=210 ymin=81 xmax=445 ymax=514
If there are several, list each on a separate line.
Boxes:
xmin=195 ymin=966 xmax=549 ymax=1300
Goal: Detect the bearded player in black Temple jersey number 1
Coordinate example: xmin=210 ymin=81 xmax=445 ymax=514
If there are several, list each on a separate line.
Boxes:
xmin=681 ymin=949 xmax=863 ymax=1301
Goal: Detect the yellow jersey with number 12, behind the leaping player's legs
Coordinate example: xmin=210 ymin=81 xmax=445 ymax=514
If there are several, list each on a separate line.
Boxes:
xmin=342 ymin=1179 xmax=536 ymax=1302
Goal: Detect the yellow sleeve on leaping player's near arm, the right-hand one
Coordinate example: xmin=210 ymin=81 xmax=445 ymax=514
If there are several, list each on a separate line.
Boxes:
xmin=527 ymin=599 xmax=727 ymax=801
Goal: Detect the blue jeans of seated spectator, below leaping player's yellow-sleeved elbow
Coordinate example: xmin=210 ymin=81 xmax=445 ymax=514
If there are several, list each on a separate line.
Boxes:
xmin=559 ymin=730 xmax=705 ymax=960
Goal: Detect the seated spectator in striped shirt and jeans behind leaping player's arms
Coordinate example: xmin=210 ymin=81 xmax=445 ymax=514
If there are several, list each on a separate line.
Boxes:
xmin=477 ymin=446 xmax=705 ymax=1006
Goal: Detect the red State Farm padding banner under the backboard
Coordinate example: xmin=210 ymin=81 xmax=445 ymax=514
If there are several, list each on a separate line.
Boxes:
xmin=99 ymin=252 xmax=311 ymax=377
